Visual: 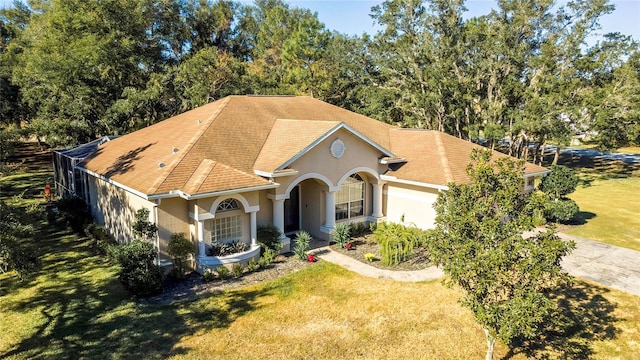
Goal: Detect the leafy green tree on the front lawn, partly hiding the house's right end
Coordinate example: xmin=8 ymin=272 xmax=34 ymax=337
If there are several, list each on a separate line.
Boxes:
xmin=430 ymin=150 xmax=575 ymax=359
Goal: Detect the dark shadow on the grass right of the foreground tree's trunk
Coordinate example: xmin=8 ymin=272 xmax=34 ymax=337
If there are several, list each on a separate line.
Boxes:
xmin=504 ymin=280 xmax=620 ymax=359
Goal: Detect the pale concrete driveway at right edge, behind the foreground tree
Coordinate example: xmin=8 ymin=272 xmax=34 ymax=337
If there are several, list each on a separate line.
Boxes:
xmin=558 ymin=233 xmax=640 ymax=296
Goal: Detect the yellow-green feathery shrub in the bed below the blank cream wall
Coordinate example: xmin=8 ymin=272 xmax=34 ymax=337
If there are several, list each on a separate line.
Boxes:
xmin=374 ymin=222 xmax=420 ymax=265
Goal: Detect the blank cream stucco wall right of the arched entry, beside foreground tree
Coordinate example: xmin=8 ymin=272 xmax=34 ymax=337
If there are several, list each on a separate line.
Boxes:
xmin=384 ymin=183 xmax=438 ymax=229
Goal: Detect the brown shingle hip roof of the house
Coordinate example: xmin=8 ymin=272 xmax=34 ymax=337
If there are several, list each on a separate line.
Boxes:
xmin=82 ymin=96 xmax=544 ymax=195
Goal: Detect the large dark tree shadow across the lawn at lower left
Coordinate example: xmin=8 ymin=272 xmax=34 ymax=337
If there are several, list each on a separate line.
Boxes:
xmin=0 ymin=218 xmax=276 ymax=359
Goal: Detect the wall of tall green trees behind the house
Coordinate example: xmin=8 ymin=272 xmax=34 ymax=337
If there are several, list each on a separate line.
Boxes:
xmin=0 ymin=0 xmax=640 ymax=155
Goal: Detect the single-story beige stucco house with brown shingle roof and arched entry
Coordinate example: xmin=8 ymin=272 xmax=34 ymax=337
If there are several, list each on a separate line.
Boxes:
xmin=67 ymin=96 xmax=547 ymax=268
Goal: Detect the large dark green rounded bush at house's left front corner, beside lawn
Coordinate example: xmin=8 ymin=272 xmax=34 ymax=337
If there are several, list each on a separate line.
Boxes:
xmin=109 ymin=240 xmax=163 ymax=297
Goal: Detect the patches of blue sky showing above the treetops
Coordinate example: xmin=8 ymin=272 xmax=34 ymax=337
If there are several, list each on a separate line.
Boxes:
xmin=0 ymin=0 xmax=640 ymax=41
